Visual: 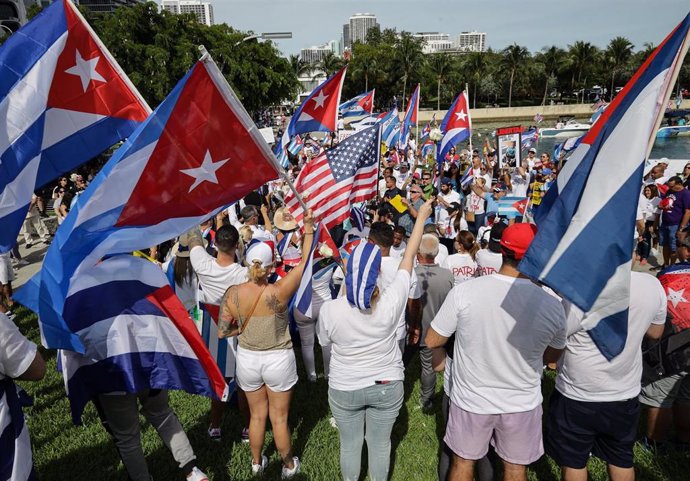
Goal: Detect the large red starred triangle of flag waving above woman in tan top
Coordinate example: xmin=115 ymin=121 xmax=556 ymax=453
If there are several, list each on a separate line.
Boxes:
xmin=116 ymin=62 xmax=278 ymax=226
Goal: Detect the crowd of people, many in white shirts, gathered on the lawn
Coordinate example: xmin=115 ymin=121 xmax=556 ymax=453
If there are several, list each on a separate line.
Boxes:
xmin=0 ymin=136 xmax=690 ymax=481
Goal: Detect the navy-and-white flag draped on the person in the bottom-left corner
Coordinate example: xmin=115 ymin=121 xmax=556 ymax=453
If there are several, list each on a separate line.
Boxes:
xmin=0 ymin=378 xmax=37 ymax=481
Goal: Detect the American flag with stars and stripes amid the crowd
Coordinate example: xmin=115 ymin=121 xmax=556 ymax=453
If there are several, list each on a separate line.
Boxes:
xmin=285 ymin=124 xmax=381 ymax=229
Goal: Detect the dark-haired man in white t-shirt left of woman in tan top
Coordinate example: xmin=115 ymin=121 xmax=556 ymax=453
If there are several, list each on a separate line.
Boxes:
xmin=180 ymin=221 xmax=249 ymax=441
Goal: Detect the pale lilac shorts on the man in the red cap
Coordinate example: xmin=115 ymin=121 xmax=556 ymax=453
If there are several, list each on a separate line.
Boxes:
xmin=443 ymin=401 xmax=544 ymax=466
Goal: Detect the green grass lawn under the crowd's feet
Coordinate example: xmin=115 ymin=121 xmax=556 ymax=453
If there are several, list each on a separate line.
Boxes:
xmin=16 ymin=309 xmax=690 ymax=481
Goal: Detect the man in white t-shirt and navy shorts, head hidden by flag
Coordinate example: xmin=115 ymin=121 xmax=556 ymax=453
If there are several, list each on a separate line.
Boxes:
xmin=545 ymin=272 xmax=666 ymax=481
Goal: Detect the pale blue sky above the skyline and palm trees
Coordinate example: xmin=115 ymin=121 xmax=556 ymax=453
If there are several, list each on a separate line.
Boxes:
xmin=210 ymin=0 xmax=690 ymax=55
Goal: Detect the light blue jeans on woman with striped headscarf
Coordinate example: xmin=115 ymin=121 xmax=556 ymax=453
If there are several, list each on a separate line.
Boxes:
xmin=328 ymin=381 xmax=404 ymax=481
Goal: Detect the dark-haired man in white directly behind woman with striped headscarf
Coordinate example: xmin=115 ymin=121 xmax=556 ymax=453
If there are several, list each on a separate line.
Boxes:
xmin=369 ymin=222 xmax=422 ymax=353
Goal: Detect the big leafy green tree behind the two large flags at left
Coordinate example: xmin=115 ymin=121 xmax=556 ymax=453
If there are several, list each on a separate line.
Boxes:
xmin=87 ymin=2 xmax=299 ymax=113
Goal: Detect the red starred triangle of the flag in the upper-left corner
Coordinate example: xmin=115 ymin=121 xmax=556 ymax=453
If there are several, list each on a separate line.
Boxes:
xmin=47 ymin=0 xmax=149 ymax=122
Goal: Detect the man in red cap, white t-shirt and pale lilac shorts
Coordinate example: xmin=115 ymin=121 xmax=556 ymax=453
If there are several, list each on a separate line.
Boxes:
xmin=426 ymin=224 xmax=566 ymax=480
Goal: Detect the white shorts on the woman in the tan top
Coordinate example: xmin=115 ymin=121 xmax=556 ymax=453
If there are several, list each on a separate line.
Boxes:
xmin=235 ymin=346 xmax=297 ymax=392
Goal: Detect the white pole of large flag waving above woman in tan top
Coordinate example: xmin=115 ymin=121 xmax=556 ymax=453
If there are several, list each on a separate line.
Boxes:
xmin=198 ymin=45 xmax=308 ymax=213
